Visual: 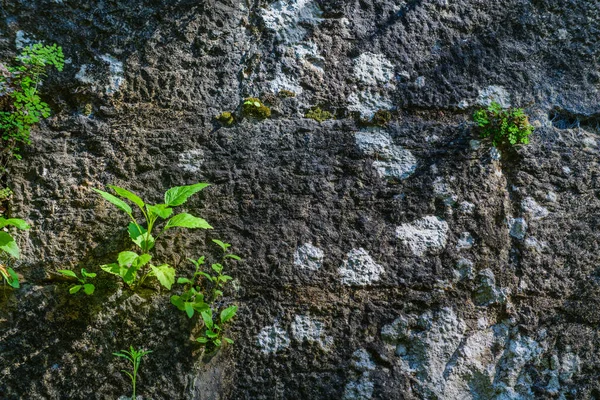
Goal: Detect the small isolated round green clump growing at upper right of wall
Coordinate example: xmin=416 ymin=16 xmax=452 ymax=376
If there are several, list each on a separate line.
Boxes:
xmin=473 ymin=102 xmax=533 ymax=148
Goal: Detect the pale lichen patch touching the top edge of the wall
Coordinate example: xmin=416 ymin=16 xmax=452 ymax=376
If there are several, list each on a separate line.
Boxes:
xmin=261 ymin=0 xmax=322 ymax=44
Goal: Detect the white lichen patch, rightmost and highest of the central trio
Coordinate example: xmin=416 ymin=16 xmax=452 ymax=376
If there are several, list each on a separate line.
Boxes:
xmin=396 ymin=215 xmax=448 ymax=257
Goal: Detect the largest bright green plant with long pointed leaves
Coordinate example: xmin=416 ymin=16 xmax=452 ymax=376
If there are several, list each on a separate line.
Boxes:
xmin=94 ymin=183 xmax=212 ymax=289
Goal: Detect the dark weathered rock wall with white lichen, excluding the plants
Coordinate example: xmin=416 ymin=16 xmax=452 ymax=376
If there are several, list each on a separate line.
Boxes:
xmin=0 ymin=0 xmax=600 ymax=400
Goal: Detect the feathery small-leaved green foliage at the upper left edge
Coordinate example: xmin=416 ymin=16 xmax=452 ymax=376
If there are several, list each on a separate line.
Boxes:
xmin=0 ymin=43 xmax=64 ymax=159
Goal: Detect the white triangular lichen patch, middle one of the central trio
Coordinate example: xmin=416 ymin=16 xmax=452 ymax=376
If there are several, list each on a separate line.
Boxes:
xmin=338 ymin=248 xmax=385 ymax=286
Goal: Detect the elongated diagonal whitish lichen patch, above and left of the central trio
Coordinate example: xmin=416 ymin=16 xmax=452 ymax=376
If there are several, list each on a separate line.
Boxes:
xmin=354 ymin=131 xmax=417 ymax=180
